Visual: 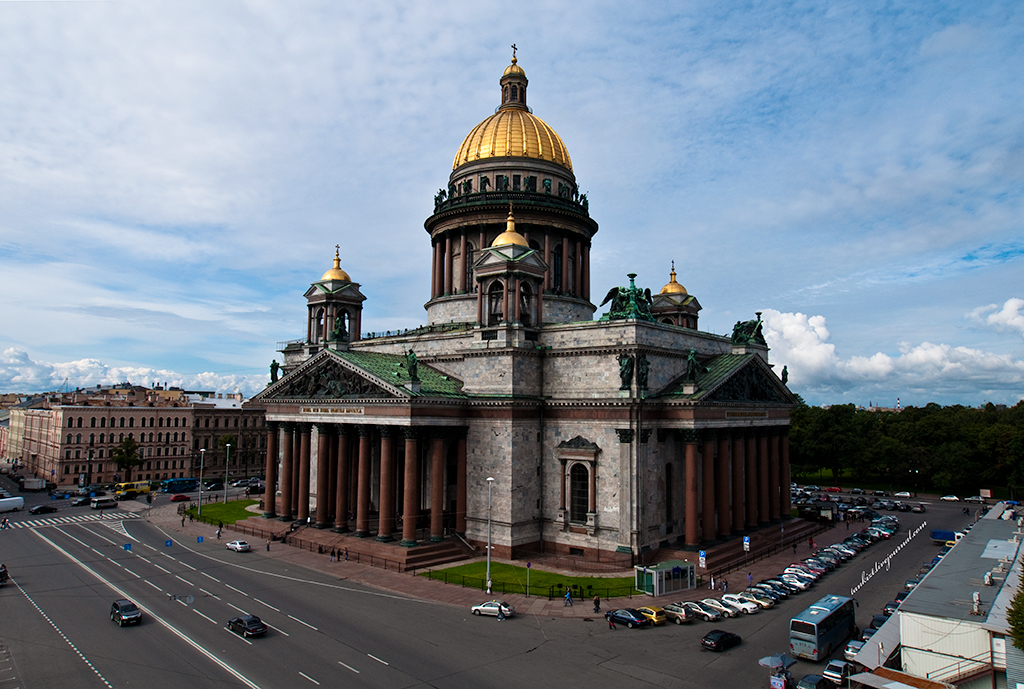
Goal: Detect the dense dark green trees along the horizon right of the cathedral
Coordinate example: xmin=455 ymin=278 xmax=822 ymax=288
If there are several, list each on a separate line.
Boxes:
xmin=790 ymin=401 xmax=1024 ymax=494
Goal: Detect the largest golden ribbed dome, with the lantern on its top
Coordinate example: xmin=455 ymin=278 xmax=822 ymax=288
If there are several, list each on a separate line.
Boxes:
xmin=452 ymin=57 xmax=572 ymax=172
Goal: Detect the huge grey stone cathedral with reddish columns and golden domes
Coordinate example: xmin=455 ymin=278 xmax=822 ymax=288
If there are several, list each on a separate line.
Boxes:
xmin=249 ymin=56 xmax=796 ymax=566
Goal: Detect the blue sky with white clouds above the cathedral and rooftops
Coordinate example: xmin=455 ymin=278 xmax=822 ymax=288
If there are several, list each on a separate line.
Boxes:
xmin=0 ymin=0 xmax=1024 ymax=406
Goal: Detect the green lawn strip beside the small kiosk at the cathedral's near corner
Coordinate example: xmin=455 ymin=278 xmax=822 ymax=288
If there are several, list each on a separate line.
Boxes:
xmin=420 ymin=562 xmax=642 ymax=599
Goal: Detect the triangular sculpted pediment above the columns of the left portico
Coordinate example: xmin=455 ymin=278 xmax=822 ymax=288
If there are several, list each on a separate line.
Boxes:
xmin=256 ymin=350 xmax=411 ymax=401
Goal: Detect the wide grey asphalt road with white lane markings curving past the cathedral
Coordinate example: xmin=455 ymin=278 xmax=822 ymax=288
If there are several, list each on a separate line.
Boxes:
xmin=0 ymin=487 xmax=968 ymax=689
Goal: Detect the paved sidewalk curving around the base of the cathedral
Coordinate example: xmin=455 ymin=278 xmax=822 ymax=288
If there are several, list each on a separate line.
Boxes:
xmin=136 ymin=503 xmax=859 ymax=618
